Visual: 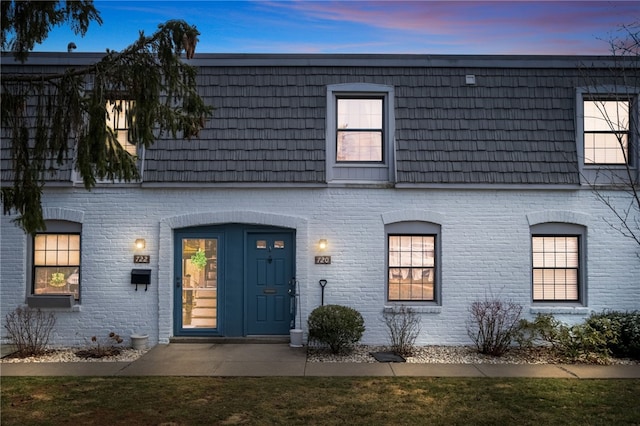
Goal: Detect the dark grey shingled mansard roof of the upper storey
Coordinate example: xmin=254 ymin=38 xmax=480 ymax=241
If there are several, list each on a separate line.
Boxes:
xmin=2 ymin=53 xmax=637 ymax=185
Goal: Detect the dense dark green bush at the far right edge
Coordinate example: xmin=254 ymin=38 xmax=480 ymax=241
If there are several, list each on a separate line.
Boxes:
xmin=587 ymin=311 xmax=640 ymax=359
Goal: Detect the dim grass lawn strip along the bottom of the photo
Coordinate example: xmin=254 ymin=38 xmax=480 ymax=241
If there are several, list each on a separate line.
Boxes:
xmin=0 ymin=377 xmax=640 ymax=426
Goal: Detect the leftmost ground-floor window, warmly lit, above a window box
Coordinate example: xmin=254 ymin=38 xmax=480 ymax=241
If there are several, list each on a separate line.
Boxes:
xmin=31 ymin=221 xmax=81 ymax=300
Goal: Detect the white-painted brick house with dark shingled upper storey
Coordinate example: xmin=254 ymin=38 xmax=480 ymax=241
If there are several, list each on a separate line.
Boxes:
xmin=0 ymin=53 xmax=640 ymax=345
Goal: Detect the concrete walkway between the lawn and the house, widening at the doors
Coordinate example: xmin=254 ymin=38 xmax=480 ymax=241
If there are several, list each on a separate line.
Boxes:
xmin=0 ymin=343 xmax=640 ymax=379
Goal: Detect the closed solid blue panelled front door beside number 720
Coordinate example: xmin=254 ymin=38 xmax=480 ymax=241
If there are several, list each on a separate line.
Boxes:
xmin=245 ymin=232 xmax=294 ymax=335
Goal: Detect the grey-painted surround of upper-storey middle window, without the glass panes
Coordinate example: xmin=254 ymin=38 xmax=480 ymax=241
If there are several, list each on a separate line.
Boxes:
xmin=326 ymin=83 xmax=395 ymax=184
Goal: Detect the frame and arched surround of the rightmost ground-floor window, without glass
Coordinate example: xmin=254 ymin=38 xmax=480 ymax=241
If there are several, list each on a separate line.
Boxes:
xmin=529 ymin=222 xmax=587 ymax=306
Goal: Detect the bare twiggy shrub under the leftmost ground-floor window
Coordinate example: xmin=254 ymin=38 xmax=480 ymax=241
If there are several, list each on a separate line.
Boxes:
xmin=4 ymin=306 xmax=56 ymax=358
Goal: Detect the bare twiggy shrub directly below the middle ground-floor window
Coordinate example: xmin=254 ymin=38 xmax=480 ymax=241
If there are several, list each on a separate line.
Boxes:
xmin=383 ymin=305 xmax=420 ymax=357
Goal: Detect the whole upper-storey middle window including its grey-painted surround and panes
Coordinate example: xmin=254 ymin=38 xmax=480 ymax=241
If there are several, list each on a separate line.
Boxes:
xmin=326 ymin=83 xmax=395 ymax=184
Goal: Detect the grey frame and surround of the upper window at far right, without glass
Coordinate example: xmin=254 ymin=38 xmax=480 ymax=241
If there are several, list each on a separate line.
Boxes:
xmin=576 ymin=86 xmax=640 ymax=185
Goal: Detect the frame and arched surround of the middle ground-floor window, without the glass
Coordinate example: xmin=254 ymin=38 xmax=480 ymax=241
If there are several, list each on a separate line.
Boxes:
xmin=384 ymin=221 xmax=442 ymax=306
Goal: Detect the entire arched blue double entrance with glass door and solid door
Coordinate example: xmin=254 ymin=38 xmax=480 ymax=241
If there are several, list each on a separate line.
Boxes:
xmin=173 ymin=224 xmax=295 ymax=337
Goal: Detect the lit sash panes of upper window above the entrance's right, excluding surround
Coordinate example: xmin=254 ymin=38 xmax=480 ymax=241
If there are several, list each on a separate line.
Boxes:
xmin=336 ymin=98 xmax=383 ymax=162
